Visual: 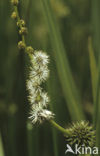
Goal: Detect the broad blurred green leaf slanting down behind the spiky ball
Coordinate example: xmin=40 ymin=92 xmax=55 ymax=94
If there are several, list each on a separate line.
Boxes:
xmin=41 ymin=0 xmax=84 ymax=120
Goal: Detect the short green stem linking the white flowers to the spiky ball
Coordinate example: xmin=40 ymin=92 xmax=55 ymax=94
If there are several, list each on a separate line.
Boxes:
xmin=49 ymin=120 xmax=70 ymax=135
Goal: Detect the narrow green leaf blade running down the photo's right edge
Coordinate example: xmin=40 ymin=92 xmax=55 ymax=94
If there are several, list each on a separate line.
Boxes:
xmin=92 ymin=0 xmax=100 ymax=152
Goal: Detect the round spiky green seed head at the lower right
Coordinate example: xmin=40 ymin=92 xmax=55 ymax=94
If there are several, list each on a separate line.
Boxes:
xmin=66 ymin=121 xmax=95 ymax=147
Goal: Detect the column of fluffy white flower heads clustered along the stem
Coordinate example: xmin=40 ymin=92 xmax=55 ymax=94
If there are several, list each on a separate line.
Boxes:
xmin=27 ymin=51 xmax=54 ymax=124
